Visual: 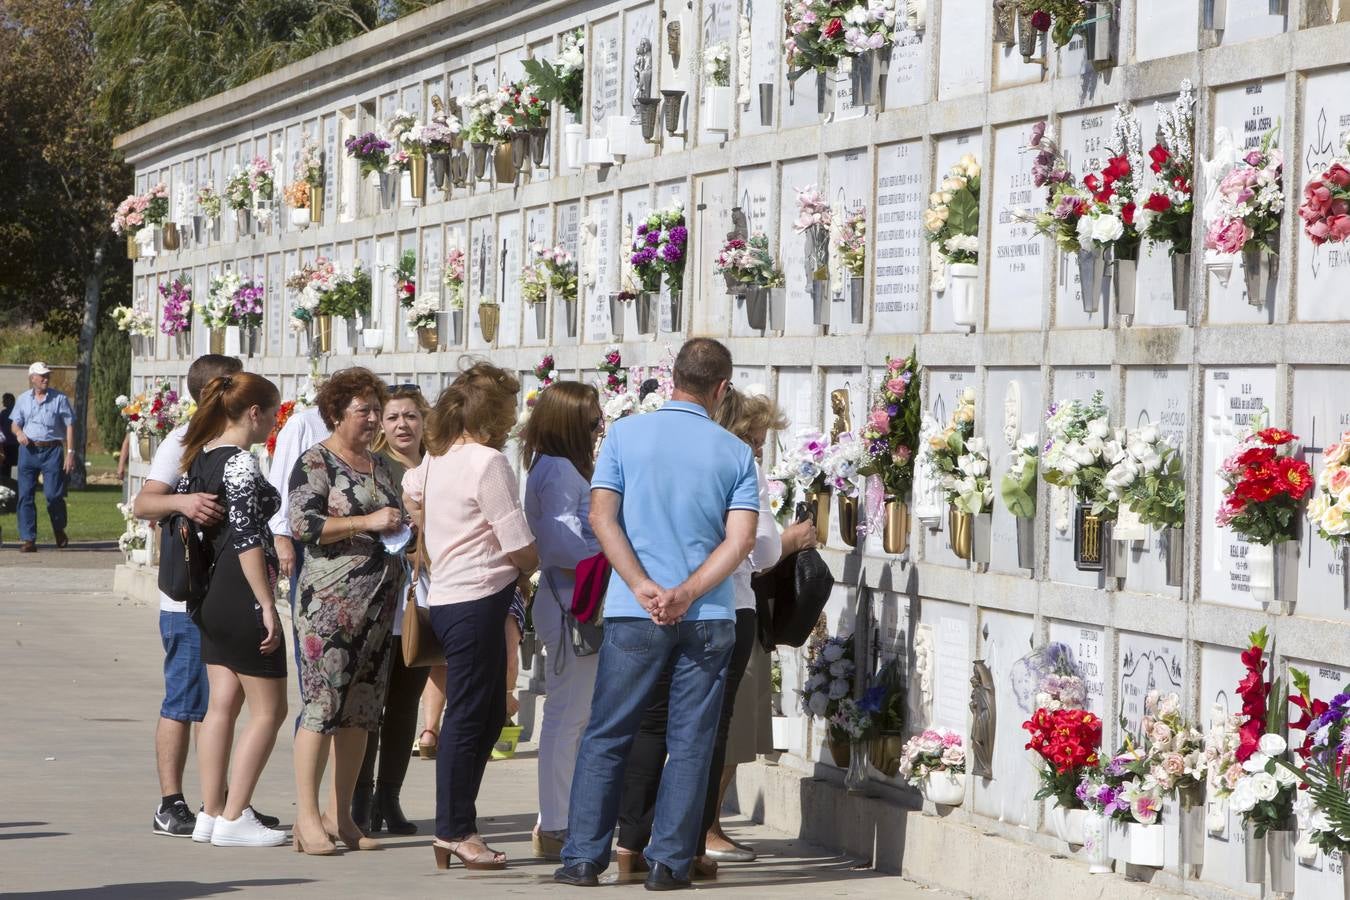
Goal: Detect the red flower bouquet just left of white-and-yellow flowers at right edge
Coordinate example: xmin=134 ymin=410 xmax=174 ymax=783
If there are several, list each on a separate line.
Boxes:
xmin=1215 ymin=428 xmax=1312 ymax=546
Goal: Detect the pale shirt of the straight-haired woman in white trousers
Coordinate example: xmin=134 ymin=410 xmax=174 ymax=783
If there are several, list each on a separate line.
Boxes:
xmin=525 ymin=456 xmax=599 ymax=610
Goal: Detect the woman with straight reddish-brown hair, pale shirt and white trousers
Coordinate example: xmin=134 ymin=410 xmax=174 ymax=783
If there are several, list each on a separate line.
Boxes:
xmin=521 ymin=382 xmax=603 ymax=860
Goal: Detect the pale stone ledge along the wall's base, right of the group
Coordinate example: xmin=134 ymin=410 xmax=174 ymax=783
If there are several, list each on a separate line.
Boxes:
xmin=729 ymin=754 xmax=1238 ymax=900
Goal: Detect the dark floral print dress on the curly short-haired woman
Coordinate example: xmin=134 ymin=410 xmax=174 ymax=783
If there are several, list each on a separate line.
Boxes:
xmin=288 ymin=444 xmax=402 ymax=734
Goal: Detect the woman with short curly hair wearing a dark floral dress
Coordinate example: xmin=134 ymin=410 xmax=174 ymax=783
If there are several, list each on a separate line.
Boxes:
xmin=289 ymin=368 xmax=409 ymax=855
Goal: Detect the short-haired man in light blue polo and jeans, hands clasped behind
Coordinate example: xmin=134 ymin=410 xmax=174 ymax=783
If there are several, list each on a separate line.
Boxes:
xmin=554 ymin=337 xmax=759 ymax=891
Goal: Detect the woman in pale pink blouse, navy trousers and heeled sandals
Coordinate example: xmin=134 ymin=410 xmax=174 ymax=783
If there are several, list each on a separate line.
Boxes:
xmin=404 ymin=363 xmax=539 ymax=869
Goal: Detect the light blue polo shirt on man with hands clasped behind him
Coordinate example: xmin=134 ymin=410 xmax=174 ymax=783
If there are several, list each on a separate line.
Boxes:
xmin=591 ymin=401 xmax=759 ymax=621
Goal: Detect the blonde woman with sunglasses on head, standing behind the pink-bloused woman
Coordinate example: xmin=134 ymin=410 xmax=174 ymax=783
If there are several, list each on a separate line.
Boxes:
xmin=351 ymin=385 xmax=434 ymax=834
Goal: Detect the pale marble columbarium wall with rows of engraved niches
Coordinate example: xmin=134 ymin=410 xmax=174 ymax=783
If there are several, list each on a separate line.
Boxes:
xmin=119 ymin=0 xmax=1350 ymax=897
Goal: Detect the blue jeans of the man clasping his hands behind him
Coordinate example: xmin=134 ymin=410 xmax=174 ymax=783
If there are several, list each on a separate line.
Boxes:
xmin=563 ymin=618 xmax=736 ymax=878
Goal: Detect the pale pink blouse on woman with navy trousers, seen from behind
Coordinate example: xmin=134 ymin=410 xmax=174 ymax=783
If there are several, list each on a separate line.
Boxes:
xmin=404 ymin=444 xmax=535 ymax=606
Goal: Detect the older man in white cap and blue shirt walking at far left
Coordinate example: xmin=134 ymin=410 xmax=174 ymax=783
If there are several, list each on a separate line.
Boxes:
xmin=9 ymin=363 xmax=76 ymax=553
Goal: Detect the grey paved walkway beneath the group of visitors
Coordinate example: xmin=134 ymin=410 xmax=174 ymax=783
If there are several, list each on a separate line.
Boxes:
xmin=0 ymin=549 xmax=949 ymax=900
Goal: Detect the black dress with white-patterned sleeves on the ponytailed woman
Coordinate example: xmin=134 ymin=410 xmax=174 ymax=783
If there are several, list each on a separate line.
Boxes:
xmin=177 ymin=445 xmax=286 ymax=679
